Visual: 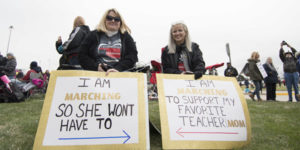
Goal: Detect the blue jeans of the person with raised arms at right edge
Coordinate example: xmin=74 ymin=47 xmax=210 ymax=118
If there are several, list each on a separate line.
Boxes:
xmin=284 ymin=72 xmax=299 ymax=101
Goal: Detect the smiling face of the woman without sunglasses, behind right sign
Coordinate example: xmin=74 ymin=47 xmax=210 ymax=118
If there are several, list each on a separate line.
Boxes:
xmin=171 ymin=24 xmax=186 ymax=45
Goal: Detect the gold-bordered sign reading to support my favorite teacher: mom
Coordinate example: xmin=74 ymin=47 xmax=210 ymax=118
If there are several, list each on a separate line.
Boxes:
xmin=158 ymin=74 xmax=251 ymax=149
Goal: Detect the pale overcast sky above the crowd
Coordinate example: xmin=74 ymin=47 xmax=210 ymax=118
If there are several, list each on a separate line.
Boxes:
xmin=0 ymin=0 xmax=300 ymax=75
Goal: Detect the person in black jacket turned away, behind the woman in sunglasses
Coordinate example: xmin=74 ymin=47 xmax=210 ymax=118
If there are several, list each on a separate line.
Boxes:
xmin=55 ymin=16 xmax=90 ymax=69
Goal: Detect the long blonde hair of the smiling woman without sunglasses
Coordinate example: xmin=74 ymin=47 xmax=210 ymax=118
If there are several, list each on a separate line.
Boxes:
xmin=168 ymin=22 xmax=192 ymax=54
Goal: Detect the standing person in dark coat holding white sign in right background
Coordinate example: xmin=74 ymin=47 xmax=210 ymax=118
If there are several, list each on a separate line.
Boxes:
xmin=263 ymin=57 xmax=278 ymax=101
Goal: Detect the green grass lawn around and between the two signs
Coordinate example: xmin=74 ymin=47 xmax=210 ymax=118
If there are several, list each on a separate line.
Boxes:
xmin=0 ymin=95 xmax=300 ymax=150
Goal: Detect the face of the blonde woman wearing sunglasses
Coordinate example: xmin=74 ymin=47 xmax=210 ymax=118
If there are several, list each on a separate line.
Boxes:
xmin=105 ymin=11 xmax=121 ymax=32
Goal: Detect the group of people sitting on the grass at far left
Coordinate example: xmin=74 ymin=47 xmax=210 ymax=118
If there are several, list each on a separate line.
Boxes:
xmin=0 ymin=53 xmax=50 ymax=102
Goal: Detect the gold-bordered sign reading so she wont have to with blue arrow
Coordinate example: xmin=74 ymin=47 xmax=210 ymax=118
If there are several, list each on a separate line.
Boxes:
xmin=33 ymin=71 xmax=150 ymax=150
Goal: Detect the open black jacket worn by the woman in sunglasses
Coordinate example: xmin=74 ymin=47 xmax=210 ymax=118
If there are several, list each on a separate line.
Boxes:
xmin=79 ymin=30 xmax=138 ymax=71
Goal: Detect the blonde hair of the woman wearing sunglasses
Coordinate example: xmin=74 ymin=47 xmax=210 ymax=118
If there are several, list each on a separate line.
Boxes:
xmin=96 ymin=8 xmax=131 ymax=34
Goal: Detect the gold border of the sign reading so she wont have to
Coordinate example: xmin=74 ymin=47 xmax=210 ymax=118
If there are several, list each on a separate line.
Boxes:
xmin=33 ymin=70 xmax=150 ymax=150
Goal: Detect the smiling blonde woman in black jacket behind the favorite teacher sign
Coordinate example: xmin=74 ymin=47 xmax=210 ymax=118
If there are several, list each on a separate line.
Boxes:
xmin=161 ymin=23 xmax=205 ymax=78
